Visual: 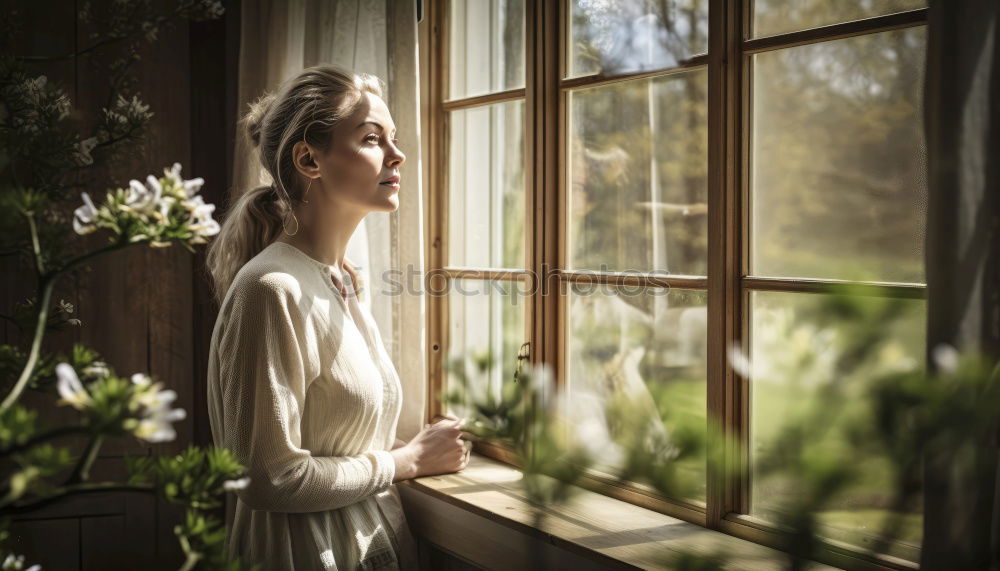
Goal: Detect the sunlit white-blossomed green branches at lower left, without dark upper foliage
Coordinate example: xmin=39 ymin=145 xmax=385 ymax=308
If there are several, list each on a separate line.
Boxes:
xmin=0 ymin=163 xmax=234 ymax=567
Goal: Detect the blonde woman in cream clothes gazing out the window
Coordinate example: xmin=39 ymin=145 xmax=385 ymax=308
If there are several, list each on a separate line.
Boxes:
xmin=207 ymin=66 xmax=468 ymax=570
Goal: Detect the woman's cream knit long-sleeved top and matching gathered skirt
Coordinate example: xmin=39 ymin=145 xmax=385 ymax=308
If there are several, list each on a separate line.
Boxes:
xmin=208 ymin=242 xmax=416 ymax=571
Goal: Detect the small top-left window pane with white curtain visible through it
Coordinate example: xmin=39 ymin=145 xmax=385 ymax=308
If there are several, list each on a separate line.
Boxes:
xmin=448 ymin=0 xmax=524 ymax=99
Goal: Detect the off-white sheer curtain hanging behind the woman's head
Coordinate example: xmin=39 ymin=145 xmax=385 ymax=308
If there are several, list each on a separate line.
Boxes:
xmin=233 ymin=0 xmax=427 ymax=440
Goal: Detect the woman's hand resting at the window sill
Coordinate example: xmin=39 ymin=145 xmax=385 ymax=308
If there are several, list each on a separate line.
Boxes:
xmin=390 ymin=418 xmax=471 ymax=481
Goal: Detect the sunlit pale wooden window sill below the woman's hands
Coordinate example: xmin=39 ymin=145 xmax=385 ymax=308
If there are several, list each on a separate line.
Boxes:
xmin=399 ymin=454 xmax=833 ymax=569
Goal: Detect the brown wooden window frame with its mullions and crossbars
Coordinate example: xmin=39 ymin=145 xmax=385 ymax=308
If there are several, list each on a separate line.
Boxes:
xmin=423 ymin=0 xmax=927 ymax=569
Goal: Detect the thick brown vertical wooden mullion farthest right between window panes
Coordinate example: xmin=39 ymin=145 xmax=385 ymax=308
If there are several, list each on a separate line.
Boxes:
xmin=706 ymin=0 xmax=749 ymax=528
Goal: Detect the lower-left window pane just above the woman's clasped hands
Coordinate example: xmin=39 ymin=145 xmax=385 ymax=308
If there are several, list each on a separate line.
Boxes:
xmin=445 ymin=279 xmax=528 ymax=417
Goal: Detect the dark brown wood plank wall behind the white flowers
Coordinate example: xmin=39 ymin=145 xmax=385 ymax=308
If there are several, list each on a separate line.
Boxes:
xmin=0 ymin=0 xmax=239 ymax=570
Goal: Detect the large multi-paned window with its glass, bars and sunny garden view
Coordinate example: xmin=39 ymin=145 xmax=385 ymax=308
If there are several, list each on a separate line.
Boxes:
xmin=431 ymin=0 xmax=927 ymax=560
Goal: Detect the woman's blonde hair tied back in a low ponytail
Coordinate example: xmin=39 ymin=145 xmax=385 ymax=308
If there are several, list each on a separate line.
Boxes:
xmin=206 ymin=64 xmax=384 ymax=304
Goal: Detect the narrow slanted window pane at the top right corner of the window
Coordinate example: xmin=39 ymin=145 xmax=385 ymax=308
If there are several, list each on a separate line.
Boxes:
xmin=753 ymin=0 xmax=927 ymax=37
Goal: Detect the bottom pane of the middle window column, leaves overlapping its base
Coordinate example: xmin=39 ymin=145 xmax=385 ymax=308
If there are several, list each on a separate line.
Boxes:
xmin=566 ymin=283 xmax=708 ymax=501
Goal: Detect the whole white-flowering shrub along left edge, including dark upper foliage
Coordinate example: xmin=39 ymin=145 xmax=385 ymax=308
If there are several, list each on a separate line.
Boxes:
xmin=0 ymin=0 xmax=254 ymax=571
